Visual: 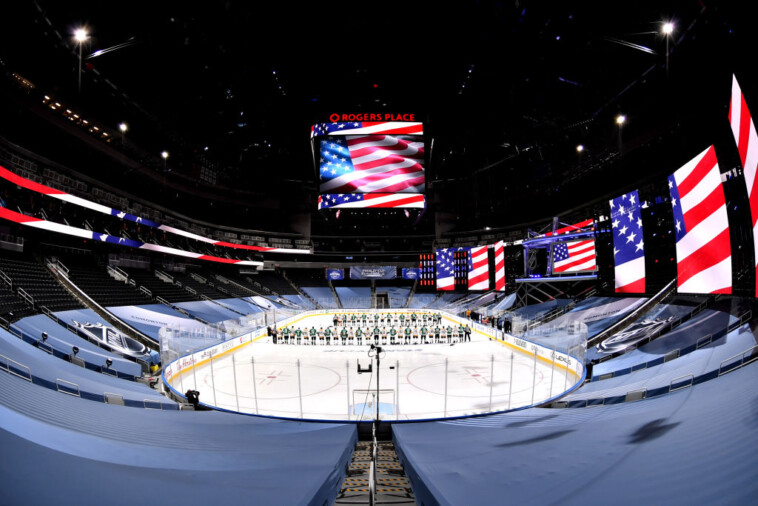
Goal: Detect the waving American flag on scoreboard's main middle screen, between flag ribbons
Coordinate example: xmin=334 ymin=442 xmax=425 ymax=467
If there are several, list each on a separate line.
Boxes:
xmin=319 ymin=135 xmax=424 ymax=193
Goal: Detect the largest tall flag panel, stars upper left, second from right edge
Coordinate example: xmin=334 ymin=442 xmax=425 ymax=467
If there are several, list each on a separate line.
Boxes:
xmin=668 ymin=146 xmax=732 ymax=294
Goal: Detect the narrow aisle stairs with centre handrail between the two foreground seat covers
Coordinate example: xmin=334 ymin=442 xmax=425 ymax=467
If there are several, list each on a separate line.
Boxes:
xmin=335 ymin=441 xmax=416 ymax=504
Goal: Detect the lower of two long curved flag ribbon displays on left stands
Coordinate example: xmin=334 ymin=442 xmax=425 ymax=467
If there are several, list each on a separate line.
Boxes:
xmin=0 ymin=207 xmax=263 ymax=266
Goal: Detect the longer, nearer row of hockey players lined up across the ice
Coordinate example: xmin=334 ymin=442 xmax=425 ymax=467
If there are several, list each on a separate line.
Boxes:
xmin=273 ymin=325 xmax=471 ymax=345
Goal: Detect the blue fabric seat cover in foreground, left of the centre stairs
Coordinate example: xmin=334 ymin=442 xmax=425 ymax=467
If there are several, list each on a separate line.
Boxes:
xmin=0 ymin=368 xmax=357 ymax=504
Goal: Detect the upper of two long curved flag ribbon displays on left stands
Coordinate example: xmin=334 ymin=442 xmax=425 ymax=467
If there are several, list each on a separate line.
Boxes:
xmin=0 ymin=166 xmax=310 ymax=254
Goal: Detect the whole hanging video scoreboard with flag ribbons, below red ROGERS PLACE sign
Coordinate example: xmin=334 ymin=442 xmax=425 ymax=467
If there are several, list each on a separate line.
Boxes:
xmin=311 ymin=119 xmax=426 ymax=209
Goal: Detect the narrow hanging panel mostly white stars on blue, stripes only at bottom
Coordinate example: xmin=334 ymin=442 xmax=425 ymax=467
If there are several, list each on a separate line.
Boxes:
xmin=610 ymin=190 xmax=645 ymax=293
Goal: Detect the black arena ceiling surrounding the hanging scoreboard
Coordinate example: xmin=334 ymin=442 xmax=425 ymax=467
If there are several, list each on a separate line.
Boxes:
xmin=0 ymin=0 xmax=758 ymax=235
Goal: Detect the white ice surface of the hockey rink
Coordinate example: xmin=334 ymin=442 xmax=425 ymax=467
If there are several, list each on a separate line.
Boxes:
xmin=180 ymin=315 xmax=578 ymax=421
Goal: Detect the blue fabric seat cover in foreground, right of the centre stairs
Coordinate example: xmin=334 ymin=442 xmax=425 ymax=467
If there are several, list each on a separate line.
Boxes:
xmin=393 ymin=364 xmax=758 ymax=505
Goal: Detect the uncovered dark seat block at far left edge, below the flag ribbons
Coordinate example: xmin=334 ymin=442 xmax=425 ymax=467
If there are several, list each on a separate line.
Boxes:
xmin=0 ymin=253 xmax=82 ymax=311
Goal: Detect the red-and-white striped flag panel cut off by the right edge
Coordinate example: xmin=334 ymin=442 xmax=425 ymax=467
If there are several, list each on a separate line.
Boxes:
xmin=729 ymin=76 xmax=758 ymax=296
